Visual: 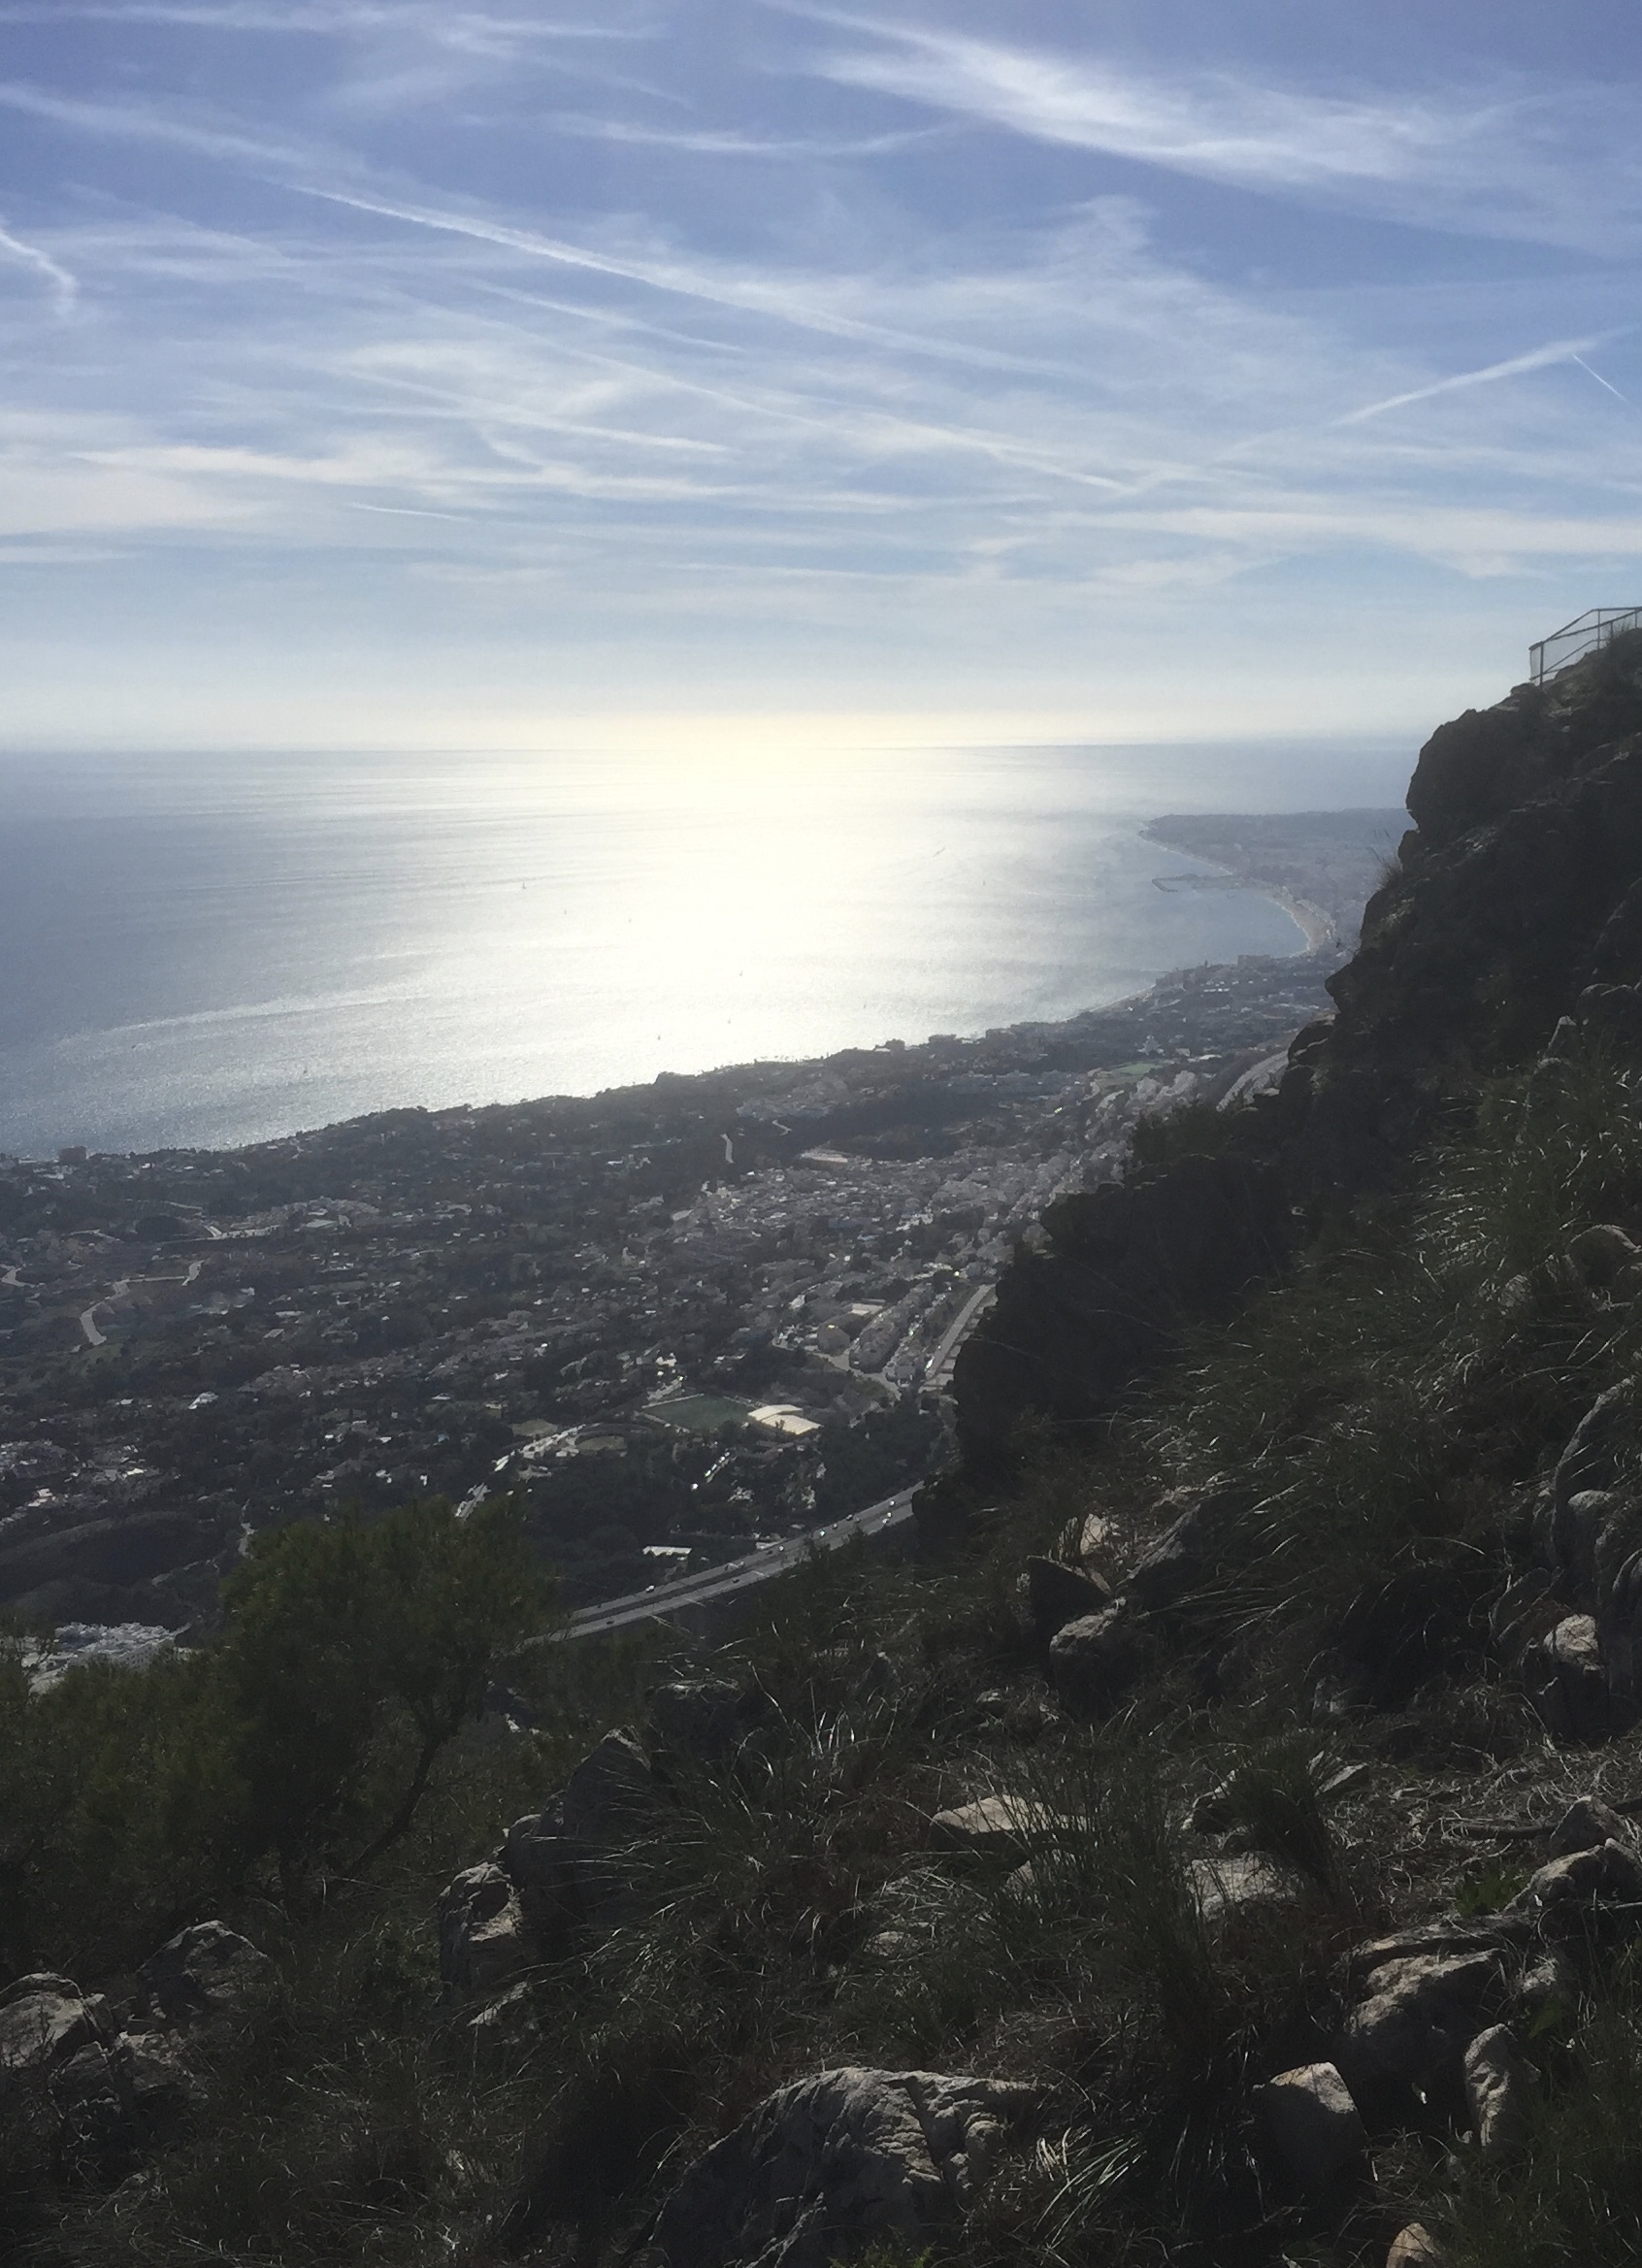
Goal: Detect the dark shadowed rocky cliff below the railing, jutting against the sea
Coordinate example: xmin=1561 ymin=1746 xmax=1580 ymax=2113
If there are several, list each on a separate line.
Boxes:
xmin=953 ymin=635 xmax=1642 ymax=1486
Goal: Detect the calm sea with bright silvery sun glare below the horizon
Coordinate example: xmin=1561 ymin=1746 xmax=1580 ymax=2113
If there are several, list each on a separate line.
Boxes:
xmin=0 ymin=746 xmax=1413 ymax=1157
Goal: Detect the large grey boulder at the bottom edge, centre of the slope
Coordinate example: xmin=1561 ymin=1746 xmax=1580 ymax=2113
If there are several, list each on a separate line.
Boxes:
xmin=655 ymin=2068 xmax=1036 ymax=2268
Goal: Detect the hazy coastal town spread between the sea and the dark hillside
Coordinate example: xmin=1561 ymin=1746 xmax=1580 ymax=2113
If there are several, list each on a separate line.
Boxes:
xmin=0 ymin=812 xmax=1397 ymax=1630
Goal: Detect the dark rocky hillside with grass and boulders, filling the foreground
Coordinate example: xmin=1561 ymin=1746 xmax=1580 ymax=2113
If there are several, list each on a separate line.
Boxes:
xmin=16 ymin=640 xmax=1642 ymax=2268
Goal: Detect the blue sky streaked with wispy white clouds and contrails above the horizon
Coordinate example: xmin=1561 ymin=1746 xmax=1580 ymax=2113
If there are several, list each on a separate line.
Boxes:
xmin=0 ymin=0 xmax=1642 ymax=753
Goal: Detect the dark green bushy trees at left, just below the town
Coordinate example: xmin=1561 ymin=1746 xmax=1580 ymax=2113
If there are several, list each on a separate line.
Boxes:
xmin=0 ymin=1503 xmax=549 ymax=1971
